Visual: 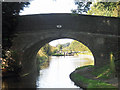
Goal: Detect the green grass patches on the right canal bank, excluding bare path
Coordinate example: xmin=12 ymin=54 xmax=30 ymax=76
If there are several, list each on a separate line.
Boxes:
xmin=71 ymin=65 xmax=117 ymax=90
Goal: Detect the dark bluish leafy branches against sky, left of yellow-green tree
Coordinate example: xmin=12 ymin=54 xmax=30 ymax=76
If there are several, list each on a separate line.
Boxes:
xmin=71 ymin=0 xmax=92 ymax=14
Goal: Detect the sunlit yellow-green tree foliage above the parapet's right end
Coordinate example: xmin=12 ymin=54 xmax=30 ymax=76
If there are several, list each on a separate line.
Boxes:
xmin=87 ymin=2 xmax=119 ymax=17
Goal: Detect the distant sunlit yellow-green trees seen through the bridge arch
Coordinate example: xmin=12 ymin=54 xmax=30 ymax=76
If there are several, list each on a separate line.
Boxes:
xmin=52 ymin=40 xmax=92 ymax=56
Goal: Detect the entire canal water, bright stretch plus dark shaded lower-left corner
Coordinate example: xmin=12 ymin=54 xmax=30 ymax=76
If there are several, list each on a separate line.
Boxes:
xmin=2 ymin=55 xmax=94 ymax=90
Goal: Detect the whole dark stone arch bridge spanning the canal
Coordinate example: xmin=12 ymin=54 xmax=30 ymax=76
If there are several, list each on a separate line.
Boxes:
xmin=12 ymin=14 xmax=119 ymax=74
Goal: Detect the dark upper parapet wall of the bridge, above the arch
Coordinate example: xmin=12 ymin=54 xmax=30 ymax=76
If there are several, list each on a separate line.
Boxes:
xmin=16 ymin=14 xmax=120 ymax=35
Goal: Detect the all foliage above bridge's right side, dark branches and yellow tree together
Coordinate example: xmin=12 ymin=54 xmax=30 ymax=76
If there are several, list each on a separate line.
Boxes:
xmin=72 ymin=0 xmax=120 ymax=17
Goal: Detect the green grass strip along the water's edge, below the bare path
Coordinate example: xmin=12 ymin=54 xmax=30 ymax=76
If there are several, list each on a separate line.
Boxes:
xmin=72 ymin=73 xmax=116 ymax=89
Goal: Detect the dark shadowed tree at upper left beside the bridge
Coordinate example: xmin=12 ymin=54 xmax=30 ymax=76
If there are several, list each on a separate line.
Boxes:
xmin=2 ymin=2 xmax=30 ymax=49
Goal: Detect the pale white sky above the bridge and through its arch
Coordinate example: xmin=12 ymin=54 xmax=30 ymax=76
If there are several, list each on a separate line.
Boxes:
xmin=20 ymin=0 xmax=77 ymax=46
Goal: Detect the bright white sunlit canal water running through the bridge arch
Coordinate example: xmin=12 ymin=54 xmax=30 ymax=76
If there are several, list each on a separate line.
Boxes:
xmin=36 ymin=55 xmax=94 ymax=88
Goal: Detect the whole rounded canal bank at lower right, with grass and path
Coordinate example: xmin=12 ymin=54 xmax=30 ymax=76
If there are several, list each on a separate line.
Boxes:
xmin=70 ymin=65 xmax=118 ymax=90
